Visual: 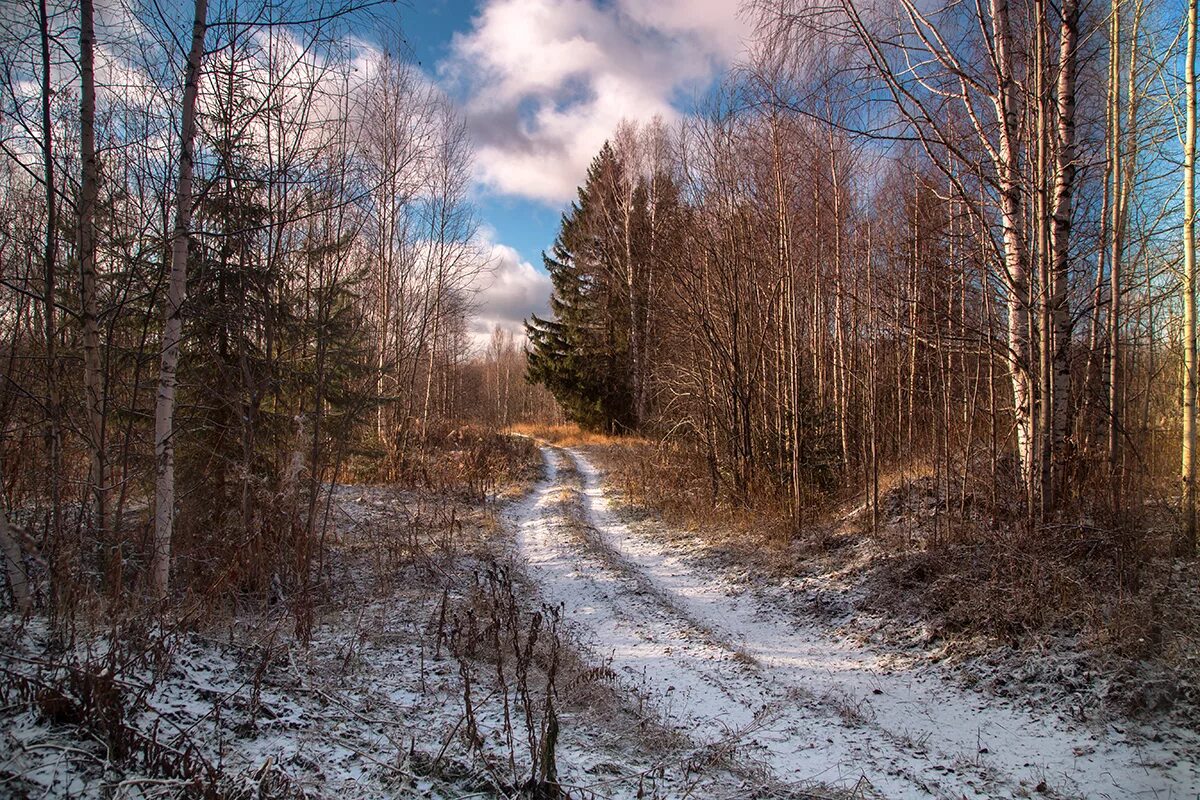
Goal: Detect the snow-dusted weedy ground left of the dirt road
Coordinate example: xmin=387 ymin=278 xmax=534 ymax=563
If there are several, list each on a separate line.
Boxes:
xmin=0 ymin=479 xmax=769 ymax=800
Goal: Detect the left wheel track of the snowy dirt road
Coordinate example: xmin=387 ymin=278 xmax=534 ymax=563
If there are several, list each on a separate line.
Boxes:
xmin=516 ymin=449 xmax=964 ymax=795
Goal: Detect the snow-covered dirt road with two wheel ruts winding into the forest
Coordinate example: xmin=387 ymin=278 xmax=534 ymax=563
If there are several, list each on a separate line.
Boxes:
xmin=511 ymin=446 xmax=1200 ymax=799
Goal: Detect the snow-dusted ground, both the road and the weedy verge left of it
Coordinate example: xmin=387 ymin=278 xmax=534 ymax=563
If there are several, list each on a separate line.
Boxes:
xmin=0 ymin=447 xmax=1200 ymax=800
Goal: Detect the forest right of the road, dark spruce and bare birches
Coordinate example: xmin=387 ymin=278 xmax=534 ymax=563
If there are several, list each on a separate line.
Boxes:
xmin=528 ymin=2 xmax=1195 ymax=542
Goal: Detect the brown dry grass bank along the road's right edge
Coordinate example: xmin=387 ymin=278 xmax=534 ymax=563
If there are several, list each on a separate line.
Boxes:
xmin=568 ymin=431 xmax=1200 ymax=722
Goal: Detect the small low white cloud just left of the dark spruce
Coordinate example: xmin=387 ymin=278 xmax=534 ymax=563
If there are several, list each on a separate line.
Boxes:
xmin=470 ymin=243 xmax=551 ymax=347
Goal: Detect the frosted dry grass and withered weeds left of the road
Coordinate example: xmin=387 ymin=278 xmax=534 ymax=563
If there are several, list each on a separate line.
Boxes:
xmin=0 ymin=432 xmax=654 ymax=800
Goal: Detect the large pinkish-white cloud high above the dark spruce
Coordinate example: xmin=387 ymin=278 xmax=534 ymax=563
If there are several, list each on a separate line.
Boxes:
xmin=439 ymin=0 xmax=746 ymax=204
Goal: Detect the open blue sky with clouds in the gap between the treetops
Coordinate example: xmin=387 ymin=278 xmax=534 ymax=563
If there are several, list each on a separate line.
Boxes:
xmin=365 ymin=0 xmax=748 ymax=335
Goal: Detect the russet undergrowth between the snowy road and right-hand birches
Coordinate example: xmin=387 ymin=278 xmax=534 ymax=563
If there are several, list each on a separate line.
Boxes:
xmin=576 ymin=424 xmax=1200 ymax=700
